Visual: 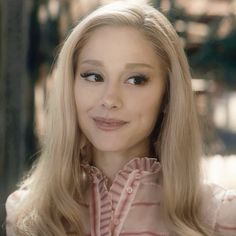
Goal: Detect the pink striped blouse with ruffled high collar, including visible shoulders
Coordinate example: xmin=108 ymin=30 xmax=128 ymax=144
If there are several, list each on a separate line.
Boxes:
xmin=6 ymin=157 xmax=236 ymax=236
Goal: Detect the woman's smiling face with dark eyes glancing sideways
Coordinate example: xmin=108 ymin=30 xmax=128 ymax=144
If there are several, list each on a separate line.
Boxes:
xmin=74 ymin=26 xmax=165 ymax=154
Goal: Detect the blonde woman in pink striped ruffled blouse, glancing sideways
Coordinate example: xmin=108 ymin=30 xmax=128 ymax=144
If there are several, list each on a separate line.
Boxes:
xmin=6 ymin=2 xmax=236 ymax=236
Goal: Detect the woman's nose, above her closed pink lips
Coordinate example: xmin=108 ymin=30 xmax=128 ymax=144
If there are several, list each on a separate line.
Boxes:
xmin=101 ymin=84 xmax=122 ymax=110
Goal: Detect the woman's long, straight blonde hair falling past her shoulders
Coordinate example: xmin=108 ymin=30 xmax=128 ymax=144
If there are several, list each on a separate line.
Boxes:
xmin=12 ymin=2 xmax=208 ymax=236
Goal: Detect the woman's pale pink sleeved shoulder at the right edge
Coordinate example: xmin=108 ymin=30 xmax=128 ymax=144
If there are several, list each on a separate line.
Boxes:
xmin=203 ymin=185 xmax=236 ymax=236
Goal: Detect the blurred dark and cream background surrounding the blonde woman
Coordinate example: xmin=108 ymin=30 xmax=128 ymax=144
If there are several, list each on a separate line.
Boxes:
xmin=0 ymin=0 xmax=236 ymax=235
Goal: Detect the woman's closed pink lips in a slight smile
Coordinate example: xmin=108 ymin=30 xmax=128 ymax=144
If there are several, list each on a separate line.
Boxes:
xmin=93 ymin=117 xmax=128 ymax=131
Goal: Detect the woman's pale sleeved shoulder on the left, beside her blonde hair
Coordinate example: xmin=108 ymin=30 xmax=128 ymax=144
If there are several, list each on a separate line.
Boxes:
xmin=5 ymin=189 xmax=28 ymax=236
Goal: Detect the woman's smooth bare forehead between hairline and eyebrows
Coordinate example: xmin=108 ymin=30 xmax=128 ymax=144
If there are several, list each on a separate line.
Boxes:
xmin=79 ymin=26 xmax=163 ymax=66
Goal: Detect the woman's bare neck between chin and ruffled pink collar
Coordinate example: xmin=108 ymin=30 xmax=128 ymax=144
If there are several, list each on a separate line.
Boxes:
xmin=93 ymin=141 xmax=149 ymax=182
